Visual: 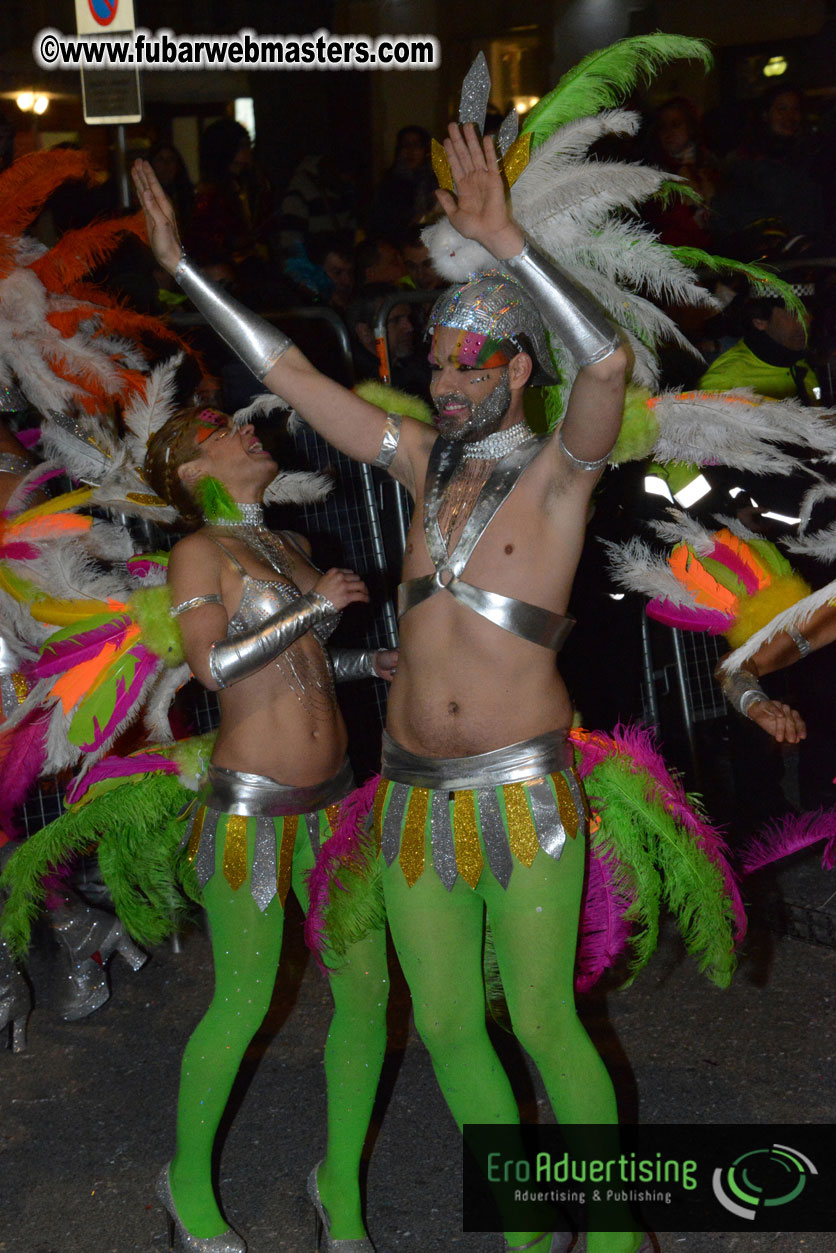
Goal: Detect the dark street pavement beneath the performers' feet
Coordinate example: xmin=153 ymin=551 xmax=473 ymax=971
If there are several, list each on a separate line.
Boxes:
xmin=0 ymin=852 xmax=836 ymax=1253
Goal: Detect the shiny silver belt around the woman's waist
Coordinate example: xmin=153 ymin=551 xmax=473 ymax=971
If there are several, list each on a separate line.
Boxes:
xmin=198 ymin=758 xmax=355 ymax=818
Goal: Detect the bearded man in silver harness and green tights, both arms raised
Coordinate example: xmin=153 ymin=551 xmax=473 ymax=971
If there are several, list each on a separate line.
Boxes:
xmin=134 ymin=117 xmax=642 ymax=1253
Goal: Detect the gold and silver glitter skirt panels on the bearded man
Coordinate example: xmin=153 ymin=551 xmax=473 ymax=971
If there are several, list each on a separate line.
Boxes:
xmin=374 ymin=766 xmax=589 ymax=891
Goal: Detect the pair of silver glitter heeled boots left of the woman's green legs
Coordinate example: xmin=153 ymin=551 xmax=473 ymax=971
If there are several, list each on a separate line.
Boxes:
xmin=50 ymin=896 xmax=148 ymax=1022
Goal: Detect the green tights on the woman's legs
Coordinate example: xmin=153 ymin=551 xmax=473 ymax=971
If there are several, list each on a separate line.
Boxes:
xmin=170 ymin=814 xmax=389 ymax=1239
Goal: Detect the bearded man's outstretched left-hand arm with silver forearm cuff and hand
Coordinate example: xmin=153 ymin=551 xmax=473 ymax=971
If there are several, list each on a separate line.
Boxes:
xmin=133 ymin=160 xmax=434 ymax=487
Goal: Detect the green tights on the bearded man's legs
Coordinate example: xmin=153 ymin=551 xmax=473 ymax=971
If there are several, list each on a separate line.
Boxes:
xmin=384 ymin=816 xmax=640 ymax=1253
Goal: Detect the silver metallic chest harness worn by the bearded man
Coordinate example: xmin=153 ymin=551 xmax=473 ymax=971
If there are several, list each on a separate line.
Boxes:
xmin=397 ymin=437 xmax=574 ymax=653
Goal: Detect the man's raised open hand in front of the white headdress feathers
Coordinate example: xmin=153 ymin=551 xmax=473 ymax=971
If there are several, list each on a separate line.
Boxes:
xmin=435 ymin=122 xmax=525 ymax=259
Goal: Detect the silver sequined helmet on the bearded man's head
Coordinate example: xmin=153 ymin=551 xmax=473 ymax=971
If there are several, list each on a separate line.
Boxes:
xmin=427 ymin=269 xmax=556 ymax=386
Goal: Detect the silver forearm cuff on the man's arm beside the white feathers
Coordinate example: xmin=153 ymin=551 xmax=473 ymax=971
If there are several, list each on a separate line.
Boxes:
xmin=500 ymin=241 xmax=620 ymax=367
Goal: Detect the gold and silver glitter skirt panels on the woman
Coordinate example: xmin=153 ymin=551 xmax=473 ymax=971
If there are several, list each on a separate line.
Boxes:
xmin=187 ymin=802 xmax=340 ymax=912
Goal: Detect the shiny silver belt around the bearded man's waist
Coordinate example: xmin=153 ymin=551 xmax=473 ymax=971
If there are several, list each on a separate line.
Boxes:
xmin=381 ymin=730 xmax=573 ymax=792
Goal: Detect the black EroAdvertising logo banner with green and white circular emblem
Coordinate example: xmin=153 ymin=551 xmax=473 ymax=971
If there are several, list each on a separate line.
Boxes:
xmin=462 ymin=1123 xmax=836 ymax=1233
